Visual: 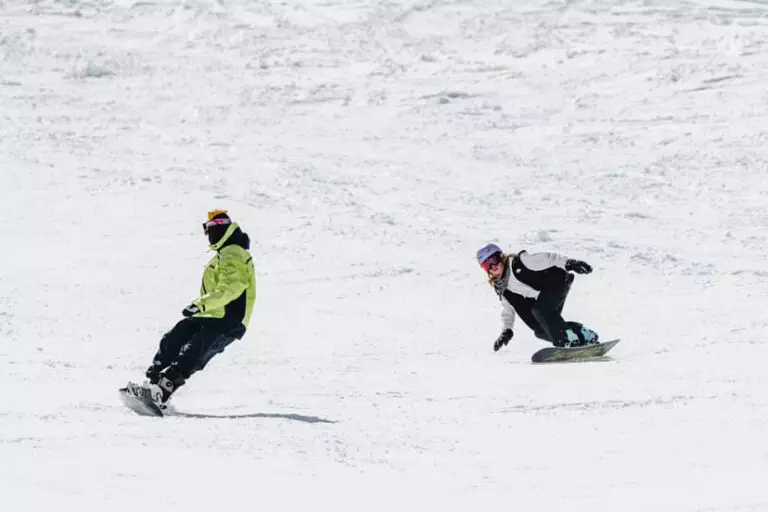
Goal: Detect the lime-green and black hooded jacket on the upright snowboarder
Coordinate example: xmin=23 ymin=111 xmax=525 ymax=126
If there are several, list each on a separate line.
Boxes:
xmin=194 ymin=222 xmax=256 ymax=327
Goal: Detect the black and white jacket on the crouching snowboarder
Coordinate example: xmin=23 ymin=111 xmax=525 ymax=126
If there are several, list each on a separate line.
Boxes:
xmin=493 ymin=251 xmax=568 ymax=329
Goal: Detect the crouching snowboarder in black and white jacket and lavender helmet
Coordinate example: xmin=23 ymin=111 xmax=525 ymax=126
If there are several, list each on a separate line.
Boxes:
xmin=477 ymin=244 xmax=598 ymax=351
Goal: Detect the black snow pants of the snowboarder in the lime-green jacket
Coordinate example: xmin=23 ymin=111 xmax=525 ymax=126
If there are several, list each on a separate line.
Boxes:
xmin=152 ymin=317 xmax=245 ymax=379
